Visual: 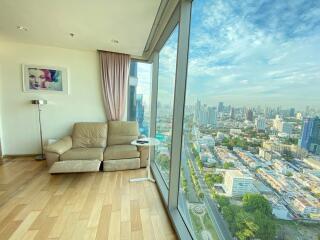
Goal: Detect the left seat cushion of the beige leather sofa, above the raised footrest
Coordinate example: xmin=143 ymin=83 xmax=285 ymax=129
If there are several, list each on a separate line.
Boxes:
xmin=60 ymin=148 xmax=104 ymax=161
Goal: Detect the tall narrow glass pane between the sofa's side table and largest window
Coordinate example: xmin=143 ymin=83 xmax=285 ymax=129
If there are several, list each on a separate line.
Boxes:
xmin=155 ymin=27 xmax=178 ymax=186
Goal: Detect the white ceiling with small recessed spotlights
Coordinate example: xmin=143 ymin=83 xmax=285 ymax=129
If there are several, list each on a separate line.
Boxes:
xmin=0 ymin=0 xmax=161 ymax=56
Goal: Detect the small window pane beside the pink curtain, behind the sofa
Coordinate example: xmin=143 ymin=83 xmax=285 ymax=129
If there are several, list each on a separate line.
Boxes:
xmin=128 ymin=61 xmax=152 ymax=136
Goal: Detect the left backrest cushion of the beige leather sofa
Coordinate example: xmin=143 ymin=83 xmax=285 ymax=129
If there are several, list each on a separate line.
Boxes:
xmin=72 ymin=123 xmax=108 ymax=148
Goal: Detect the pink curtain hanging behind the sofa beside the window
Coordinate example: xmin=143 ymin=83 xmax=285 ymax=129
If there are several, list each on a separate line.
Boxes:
xmin=99 ymin=51 xmax=130 ymax=120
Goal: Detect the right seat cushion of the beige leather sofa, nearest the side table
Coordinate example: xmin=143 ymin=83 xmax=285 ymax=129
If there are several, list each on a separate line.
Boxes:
xmin=103 ymin=145 xmax=140 ymax=160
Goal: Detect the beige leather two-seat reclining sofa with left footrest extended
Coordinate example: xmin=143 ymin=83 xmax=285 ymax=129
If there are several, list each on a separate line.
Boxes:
xmin=45 ymin=121 xmax=148 ymax=172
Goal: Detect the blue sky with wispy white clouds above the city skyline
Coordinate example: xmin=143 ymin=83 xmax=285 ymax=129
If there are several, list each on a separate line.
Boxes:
xmin=138 ymin=0 xmax=320 ymax=108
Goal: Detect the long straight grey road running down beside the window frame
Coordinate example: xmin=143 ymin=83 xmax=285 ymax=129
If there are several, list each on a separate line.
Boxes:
xmin=182 ymin=138 xmax=232 ymax=240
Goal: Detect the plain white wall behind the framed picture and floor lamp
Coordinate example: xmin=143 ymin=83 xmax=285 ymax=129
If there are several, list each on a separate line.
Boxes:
xmin=0 ymin=42 xmax=106 ymax=155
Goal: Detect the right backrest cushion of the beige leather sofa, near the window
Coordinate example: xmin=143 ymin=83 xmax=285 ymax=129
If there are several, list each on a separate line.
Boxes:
xmin=108 ymin=121 xmax=139 ymax=146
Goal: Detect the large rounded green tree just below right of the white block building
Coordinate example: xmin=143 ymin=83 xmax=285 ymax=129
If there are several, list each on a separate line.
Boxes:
xmin=242 ymin=193 xmax=272 ymax=217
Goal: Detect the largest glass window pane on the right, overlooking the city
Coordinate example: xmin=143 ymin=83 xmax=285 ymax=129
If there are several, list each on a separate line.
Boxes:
xmin=179 ymin=0 xmax=320 ymax=240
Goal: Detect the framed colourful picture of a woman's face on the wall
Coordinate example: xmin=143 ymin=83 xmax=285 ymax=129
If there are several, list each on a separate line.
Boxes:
xmin=22 ymin=64 xmax=68 ymax=94
